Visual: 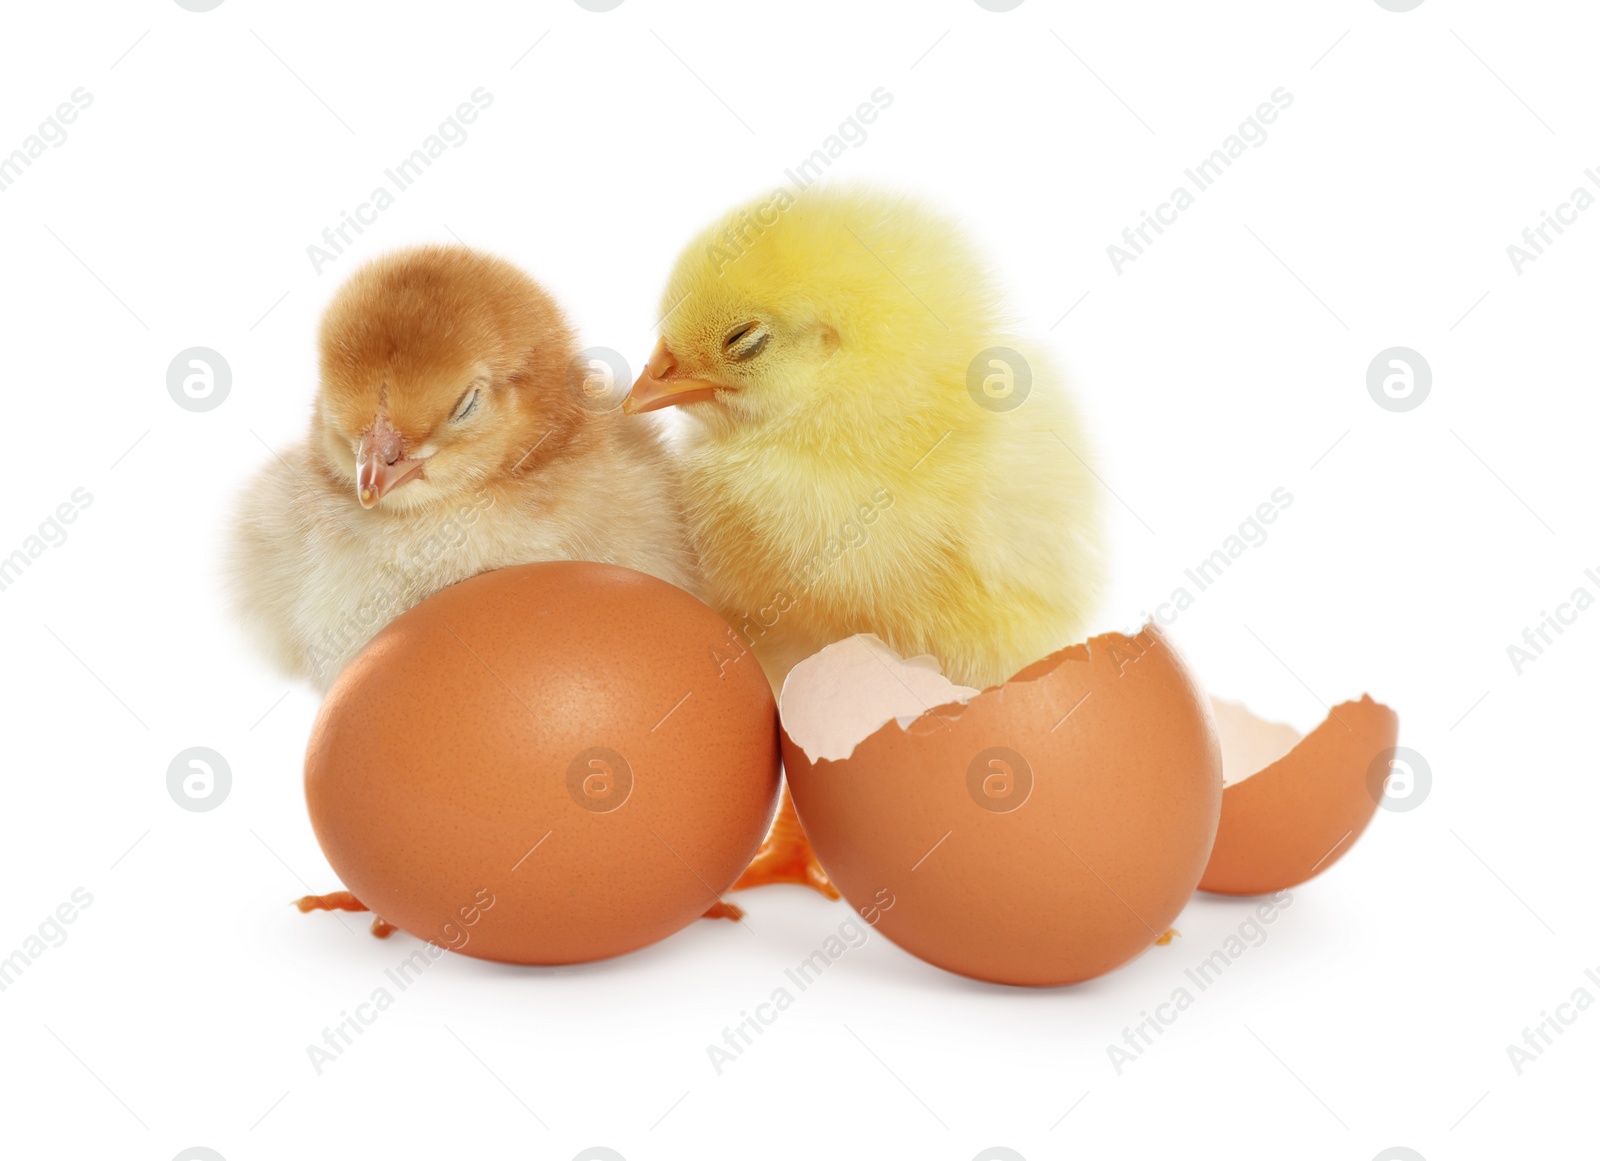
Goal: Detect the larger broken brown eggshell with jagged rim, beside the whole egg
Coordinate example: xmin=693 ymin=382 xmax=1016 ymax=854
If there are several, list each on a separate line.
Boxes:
xmin=782 ymin=627 xmax=1222 ymax=985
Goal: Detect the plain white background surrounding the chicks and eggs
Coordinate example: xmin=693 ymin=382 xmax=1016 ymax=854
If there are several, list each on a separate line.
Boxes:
xmin=0 ymin=0 xmax=1600 ymax=1161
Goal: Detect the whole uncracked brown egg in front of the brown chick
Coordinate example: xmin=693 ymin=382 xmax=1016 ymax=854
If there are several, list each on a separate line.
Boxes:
xmin=306 ymin=561 xmax=778 ymax=964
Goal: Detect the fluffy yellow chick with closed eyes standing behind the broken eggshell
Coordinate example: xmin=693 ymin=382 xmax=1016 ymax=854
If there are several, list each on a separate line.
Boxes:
xmin=624 ymin=187 xmax=1102 ymax=886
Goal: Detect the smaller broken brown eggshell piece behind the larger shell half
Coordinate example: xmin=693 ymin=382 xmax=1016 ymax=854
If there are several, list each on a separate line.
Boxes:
xmin=1200 ymin=697 xmax=1400 ymax=896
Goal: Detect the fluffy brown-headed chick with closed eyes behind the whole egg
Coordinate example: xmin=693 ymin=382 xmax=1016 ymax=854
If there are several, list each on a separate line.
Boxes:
xmin=232 ymin=246 xmax=701 ymax=689
